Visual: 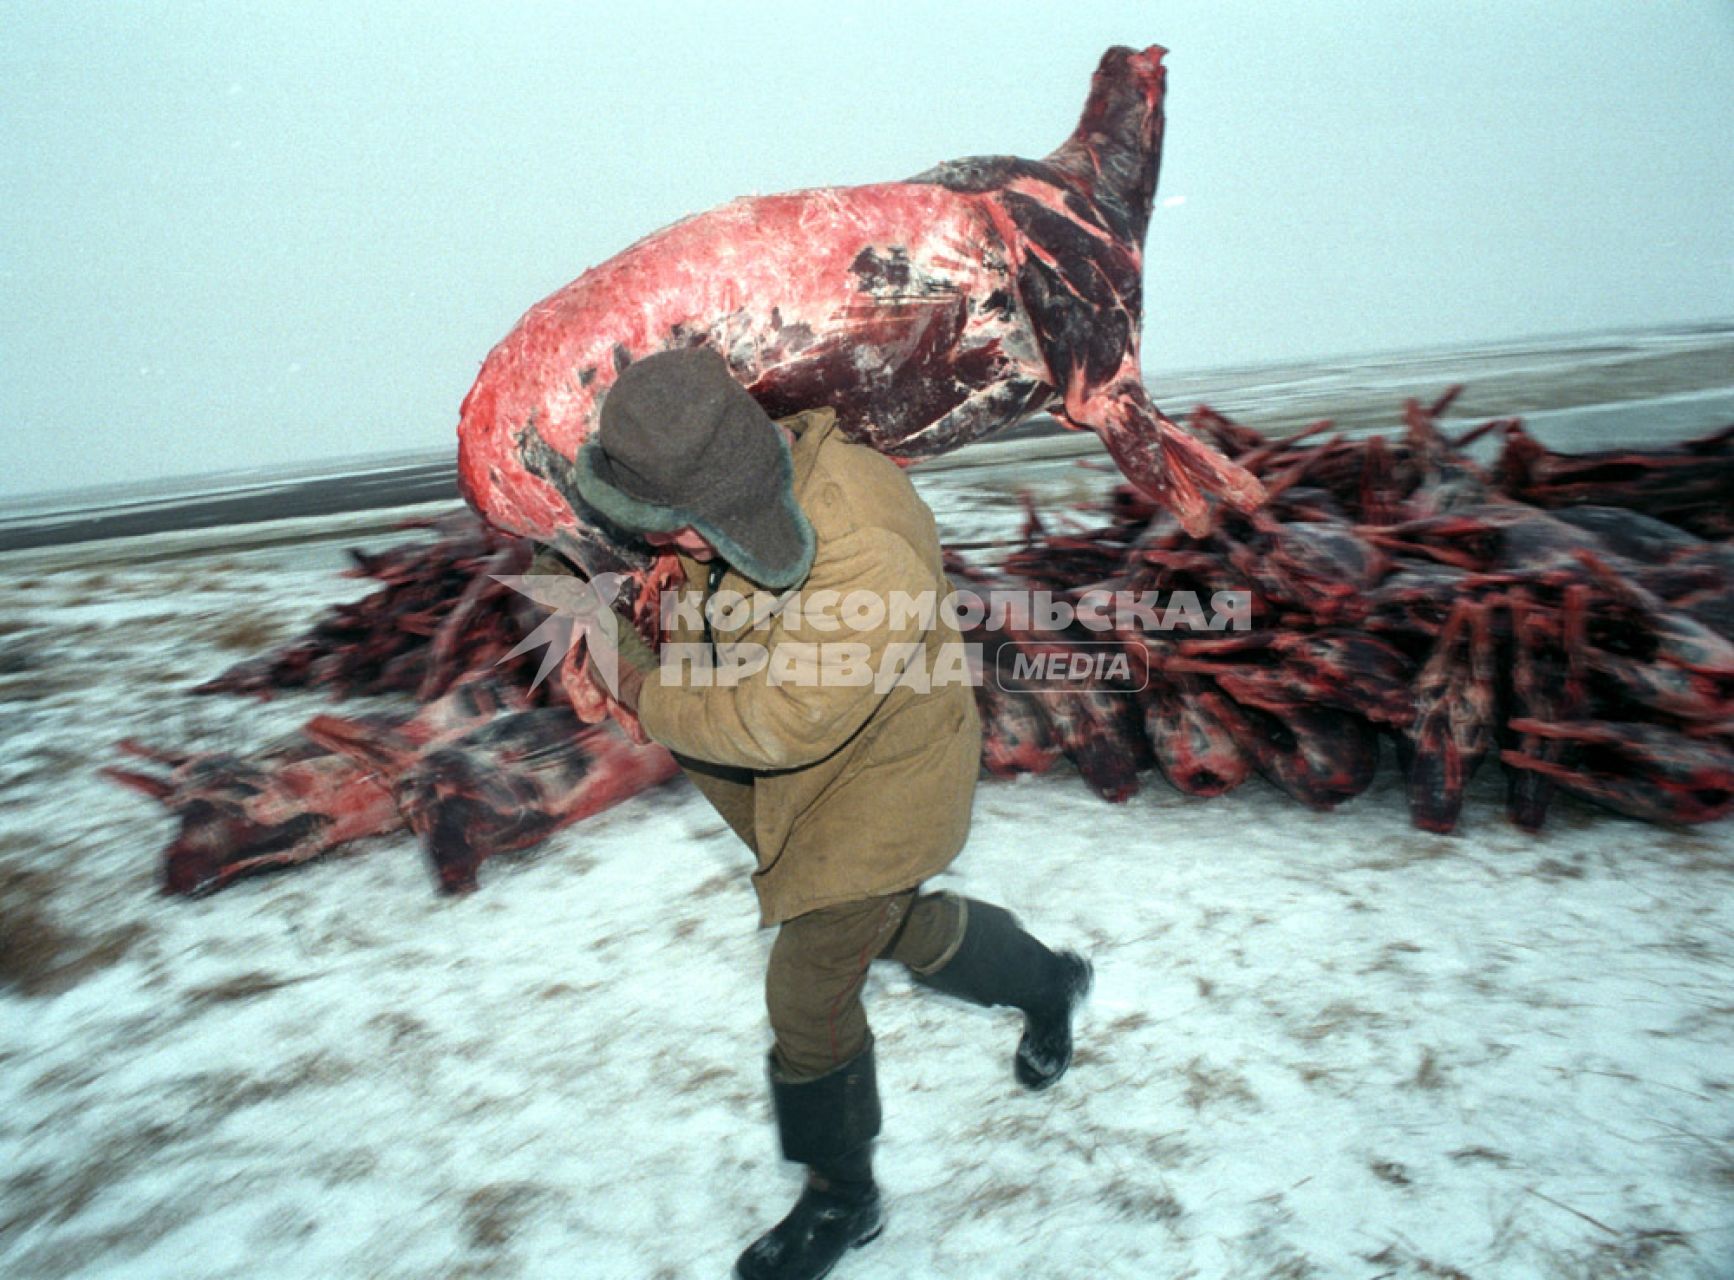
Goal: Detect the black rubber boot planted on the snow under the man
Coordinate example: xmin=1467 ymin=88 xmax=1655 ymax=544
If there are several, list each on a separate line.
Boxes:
xmin=735 ymin=1041 xmax=884 ymax=1280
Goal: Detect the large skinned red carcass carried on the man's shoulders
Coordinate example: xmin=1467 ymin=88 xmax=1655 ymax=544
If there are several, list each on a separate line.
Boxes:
xmin=458 ymin=47 xmax=1262 ymax=574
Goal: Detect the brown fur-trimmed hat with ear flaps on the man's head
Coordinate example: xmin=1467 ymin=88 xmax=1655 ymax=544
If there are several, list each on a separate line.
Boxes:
xmin=572 ymin=347 xmax=817 ymax=591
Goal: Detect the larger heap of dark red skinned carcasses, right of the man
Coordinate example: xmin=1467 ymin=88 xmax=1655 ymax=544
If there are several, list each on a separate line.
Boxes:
xmin=957 ymin=389 xmax=1734 ymax=831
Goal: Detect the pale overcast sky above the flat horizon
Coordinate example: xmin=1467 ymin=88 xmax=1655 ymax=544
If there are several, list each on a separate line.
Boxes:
xmin=0 ymin=0 xmax=1734 ymax=494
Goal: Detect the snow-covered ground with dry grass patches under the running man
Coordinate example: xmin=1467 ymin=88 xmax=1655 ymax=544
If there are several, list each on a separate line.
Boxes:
xmin=0 ymin=463 xmax=1734 ymax=1280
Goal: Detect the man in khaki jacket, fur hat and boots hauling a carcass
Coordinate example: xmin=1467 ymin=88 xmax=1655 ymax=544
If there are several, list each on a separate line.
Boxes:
xmin=572 ymin=347 xmax=1091 ymax=1280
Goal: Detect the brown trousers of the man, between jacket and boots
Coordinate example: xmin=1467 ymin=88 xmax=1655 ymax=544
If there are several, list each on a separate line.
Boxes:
xmin=765 ymin=890 xmax=966 ymax=1081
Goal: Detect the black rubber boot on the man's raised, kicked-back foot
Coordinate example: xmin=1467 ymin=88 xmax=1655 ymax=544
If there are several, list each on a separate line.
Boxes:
xmin=916 ymin=898 xmax=1094 ymax=1091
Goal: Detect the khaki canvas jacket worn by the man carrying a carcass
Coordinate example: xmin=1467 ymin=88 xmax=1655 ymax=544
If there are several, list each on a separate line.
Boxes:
xmin=638 ymin=409 xmax=981 ymax=924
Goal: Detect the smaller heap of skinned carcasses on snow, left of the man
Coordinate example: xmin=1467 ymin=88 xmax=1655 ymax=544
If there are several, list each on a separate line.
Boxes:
xmin=104 ymin=513 xmax=678 ymax=895
